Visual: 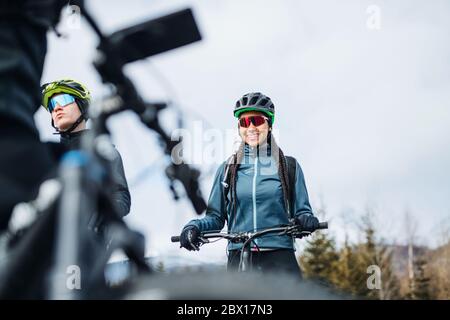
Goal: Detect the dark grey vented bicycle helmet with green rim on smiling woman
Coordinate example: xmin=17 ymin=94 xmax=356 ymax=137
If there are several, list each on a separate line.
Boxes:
xmin=233 ymin=92 xmax=275 ymax=125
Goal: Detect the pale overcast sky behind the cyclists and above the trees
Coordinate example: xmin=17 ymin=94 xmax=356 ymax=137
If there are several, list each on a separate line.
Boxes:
xmin=36 ymin=0 xmax=450 ymax=260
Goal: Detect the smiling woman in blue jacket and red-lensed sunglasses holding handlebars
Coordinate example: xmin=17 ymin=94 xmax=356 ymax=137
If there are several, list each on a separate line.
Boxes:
xmin=180 ymin=92 xmax=319 ymax=274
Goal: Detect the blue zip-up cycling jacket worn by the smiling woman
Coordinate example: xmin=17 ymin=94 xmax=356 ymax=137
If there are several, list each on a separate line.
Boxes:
xmin=186 ymin=145 xmax=312 ymax=250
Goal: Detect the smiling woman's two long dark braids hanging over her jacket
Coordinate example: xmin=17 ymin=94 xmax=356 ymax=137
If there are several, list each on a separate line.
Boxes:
xmin=228 ymin=131 xmax=292 ymax=225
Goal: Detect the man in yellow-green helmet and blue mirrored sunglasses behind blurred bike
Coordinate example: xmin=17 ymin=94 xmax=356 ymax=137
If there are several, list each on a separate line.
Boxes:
xmin=42 ymin=79 xmax=131 ymax=220
